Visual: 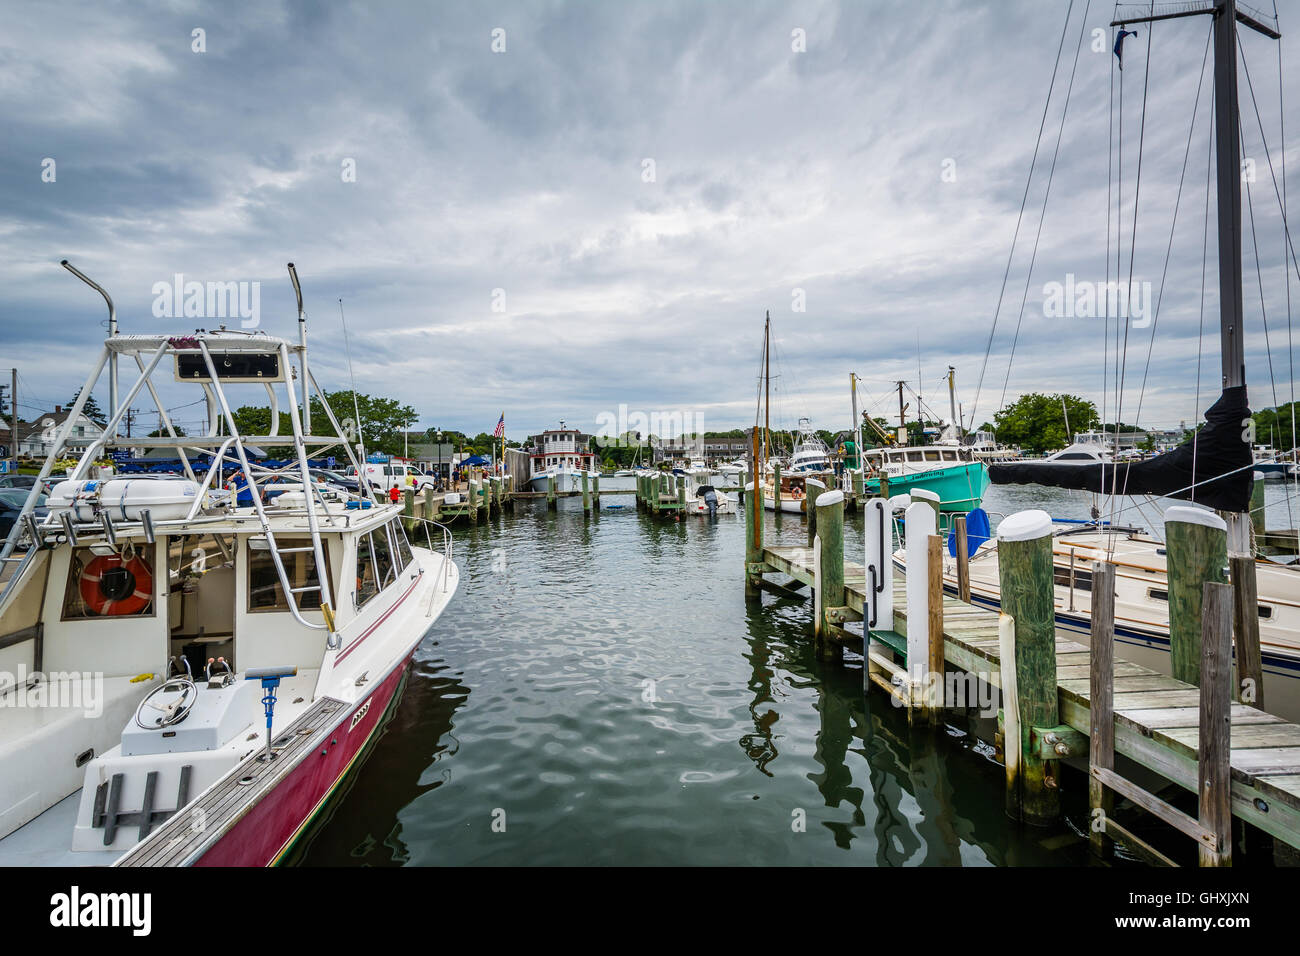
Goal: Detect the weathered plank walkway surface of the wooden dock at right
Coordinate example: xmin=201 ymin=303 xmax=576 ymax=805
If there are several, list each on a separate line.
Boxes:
xmin=763 ymin=545 xmax=1300 ymax=847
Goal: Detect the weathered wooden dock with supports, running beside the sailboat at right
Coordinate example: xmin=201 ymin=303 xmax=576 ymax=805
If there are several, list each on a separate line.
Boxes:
xmin=746 ymin=481 xmax=1300 ymax=865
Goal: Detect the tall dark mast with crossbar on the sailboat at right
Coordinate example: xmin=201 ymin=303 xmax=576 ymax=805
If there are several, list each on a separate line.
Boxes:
xmin=1110 ymin=0 xmax=1284 ymax=554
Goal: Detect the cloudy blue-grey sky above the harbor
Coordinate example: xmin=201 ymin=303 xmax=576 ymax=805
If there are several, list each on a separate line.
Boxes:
xmin=0 ymin=0 xmax=1300 ymax=436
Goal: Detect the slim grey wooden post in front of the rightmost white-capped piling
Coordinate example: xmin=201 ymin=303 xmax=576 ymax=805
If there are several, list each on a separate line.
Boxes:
xmin=1196 ymin=581 xmax=1232 ymax=866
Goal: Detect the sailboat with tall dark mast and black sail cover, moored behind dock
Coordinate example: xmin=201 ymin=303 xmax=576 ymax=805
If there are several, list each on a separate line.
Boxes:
xmin=894 ymin=0 xmax=1300 ymax=719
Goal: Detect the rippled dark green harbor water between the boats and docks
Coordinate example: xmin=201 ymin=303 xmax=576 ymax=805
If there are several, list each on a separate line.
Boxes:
xmin=302 ymin=479 xmax=1294 ymax=866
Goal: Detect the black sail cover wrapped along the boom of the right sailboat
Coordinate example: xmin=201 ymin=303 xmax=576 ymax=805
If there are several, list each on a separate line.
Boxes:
xmin=988 ymin=385 xmax=1255 ymax=511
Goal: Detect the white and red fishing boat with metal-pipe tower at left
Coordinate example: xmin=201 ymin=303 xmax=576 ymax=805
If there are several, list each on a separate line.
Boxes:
xmin=0 ymin=265 xmax=458 ymax=866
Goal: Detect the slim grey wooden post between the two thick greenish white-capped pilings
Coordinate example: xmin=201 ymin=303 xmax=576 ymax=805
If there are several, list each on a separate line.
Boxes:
xmin=1088 ymin=561 xmax=1115 ymax=858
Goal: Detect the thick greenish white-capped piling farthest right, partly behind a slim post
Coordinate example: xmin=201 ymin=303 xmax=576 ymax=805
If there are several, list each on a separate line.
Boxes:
xmin=1165 ymin=505 xmax=1227 ymax=687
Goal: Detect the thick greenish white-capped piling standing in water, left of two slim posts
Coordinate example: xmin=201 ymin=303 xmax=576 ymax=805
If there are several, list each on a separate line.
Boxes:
xmin=997 ymin=510 xmax=1061 ymax=826
